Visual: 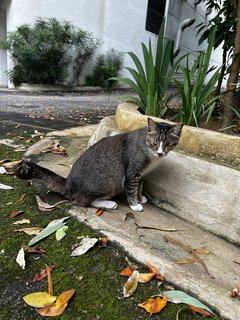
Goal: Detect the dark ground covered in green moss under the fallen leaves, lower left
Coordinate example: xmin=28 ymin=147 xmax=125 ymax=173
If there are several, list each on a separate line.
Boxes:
xmin=0 ymin=132 xmax=218 ymax=320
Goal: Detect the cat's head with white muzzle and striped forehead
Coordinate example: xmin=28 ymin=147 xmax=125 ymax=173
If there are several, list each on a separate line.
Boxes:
xmin=147 ymin=118 xmax=183 ymax=157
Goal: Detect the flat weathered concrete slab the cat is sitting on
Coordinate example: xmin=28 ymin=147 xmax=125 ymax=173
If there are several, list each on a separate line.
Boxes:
xmin=20 ymin=126 xmax=240 ymax=320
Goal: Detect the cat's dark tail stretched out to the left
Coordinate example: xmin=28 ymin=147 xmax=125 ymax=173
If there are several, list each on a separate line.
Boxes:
xmin=15 ymin=160 xmax=66 ymax=195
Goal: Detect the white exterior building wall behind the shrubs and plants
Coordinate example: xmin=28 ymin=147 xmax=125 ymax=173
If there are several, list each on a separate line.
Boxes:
xmin=0 ymin=0 xmax=224 ymax=84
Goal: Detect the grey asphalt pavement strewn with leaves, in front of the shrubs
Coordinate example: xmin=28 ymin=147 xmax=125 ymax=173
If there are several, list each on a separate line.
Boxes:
xmin=0 ymin=90 xmax=126 ymax=134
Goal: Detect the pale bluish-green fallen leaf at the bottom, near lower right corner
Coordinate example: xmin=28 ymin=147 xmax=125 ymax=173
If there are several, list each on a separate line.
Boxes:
xmin=163 ymin=290 xmax=214 ymax=314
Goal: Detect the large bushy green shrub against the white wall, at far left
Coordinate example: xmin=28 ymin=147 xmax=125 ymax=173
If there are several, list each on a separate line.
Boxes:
xmin=0 ymin=18 xmax=99 ymax=84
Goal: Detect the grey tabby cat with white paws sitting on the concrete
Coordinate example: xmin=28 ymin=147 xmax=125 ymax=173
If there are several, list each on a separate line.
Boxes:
xmin=16 ymin=118 xmax=183 ymax=211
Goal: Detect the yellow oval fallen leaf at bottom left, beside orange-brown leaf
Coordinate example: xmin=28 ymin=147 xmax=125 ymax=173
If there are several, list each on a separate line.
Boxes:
xmin=23 ymin=292 xmax=57 ymax=308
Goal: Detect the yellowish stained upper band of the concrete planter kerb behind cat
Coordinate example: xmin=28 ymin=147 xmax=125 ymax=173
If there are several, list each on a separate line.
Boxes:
xmin=115 ymin=103 xmax=240 ymax=169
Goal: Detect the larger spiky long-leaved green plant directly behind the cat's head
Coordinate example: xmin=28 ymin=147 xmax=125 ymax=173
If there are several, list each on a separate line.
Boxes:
xmin=111 ymin=21 xmax=183 ymax=116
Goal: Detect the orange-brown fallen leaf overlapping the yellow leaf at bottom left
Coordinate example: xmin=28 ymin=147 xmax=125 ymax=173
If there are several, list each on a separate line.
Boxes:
xmin=37 ymin=289 xmax=75 ymax=317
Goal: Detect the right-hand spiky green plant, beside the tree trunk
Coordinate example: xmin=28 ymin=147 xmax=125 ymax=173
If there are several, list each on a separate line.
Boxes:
xmin=174 ymin=32 xmax=220 ymax=126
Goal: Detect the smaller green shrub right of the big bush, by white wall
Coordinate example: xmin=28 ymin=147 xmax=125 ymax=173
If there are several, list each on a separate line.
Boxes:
xmin=86 ymin=49 xmax=123 ymax=87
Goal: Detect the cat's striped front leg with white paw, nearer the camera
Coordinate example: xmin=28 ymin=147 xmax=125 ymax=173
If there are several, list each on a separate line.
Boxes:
xmin=126 ymin=176 xmax=143 ymax=211
